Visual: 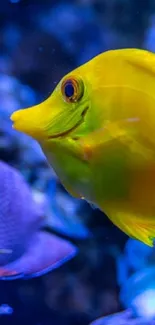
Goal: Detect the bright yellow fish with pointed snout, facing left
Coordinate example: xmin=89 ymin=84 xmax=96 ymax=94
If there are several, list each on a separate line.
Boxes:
xmin=11 ymin=49 xmax=155 ymax=246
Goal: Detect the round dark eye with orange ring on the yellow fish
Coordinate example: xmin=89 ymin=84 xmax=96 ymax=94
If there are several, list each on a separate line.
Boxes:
xmin=61 ymin=77 xmax=84 ymax=103
